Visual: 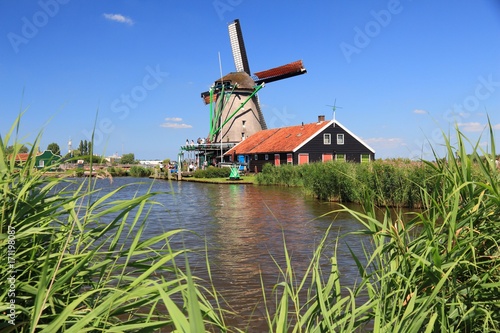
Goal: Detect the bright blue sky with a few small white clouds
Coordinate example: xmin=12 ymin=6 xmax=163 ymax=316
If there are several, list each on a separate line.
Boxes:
xmin=0 ymin=0 xmax=500 ymax=159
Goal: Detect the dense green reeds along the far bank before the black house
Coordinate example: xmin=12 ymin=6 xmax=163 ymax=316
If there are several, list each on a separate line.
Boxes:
xmin=256 ymin=153 xmax=498 ymax=208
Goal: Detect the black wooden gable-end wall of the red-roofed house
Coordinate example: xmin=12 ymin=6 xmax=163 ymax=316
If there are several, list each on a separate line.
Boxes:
xmin=294 ymin=124 xmax=375 ymax=164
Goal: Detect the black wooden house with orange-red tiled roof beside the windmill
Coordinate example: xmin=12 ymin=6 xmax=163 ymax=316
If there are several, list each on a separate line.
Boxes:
xmin=224 ymin=116 xmax=375 ymax=172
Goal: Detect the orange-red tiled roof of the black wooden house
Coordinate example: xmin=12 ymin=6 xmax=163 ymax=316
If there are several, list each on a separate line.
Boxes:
xmin=225 ymin=121 xmax=332 ymax=155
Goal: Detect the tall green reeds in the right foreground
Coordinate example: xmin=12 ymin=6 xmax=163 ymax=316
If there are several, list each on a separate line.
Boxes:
xmin=264 ymin=126 xmax=500 ymax=333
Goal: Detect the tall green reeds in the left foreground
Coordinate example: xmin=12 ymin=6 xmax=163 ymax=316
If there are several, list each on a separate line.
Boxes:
xmin=0 ymin=115 xmax=223 ymax=333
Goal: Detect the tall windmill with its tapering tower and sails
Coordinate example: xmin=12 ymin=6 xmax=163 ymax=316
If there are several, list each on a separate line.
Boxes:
xmin=201 ymin=19 xmax=307 ymax=143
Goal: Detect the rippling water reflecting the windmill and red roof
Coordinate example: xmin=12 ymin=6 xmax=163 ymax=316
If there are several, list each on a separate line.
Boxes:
xmin=75 ymin=178 xmax=372 ymax=332
